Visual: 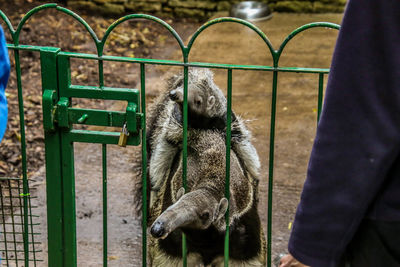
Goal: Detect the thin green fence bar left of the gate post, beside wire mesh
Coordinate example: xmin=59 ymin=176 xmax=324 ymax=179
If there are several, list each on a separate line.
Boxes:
xmin=14 ymin=50 xmax=29 ymax=267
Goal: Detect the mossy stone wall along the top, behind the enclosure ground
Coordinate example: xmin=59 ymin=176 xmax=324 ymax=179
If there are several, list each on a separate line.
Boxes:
xmin=67 ymin=0 xmax=346 ymax=19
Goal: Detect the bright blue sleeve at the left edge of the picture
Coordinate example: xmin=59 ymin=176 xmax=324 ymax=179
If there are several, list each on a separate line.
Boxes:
xmin=0 ymin=26 xmax=10 ymax=141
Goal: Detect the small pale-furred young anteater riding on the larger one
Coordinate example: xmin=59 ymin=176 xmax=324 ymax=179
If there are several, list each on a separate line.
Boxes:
xmin=147 ymin=68 xmax=260 ymax=205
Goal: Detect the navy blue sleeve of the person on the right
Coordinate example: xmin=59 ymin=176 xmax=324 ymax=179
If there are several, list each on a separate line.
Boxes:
xmin=289 ymin=0 xmax=400 ymax=267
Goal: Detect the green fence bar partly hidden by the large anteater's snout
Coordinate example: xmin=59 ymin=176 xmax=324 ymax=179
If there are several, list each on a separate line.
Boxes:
xmin=182 ymin=66 xmax=189 ymax=267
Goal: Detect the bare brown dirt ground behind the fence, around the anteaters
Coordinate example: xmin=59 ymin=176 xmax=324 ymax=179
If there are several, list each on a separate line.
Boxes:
xmin=0 ymin=1 xmax=341 ymax=266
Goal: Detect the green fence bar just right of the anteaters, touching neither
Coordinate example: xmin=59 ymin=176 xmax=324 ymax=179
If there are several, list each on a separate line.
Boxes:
xmin=267 ymin=70 xmax=278 ymax=267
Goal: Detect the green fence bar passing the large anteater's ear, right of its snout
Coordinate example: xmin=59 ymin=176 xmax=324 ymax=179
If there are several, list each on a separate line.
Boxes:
xmin=224 ymin=69 xmax=232 ymax=267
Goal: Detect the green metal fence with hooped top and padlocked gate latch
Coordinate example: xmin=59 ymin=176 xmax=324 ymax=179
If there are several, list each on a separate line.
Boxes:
xmin=0 ymin=4 xmax=339 ymax=267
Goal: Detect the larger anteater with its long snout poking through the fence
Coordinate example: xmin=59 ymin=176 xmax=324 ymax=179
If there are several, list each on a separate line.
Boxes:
xmin=149 ymin=129 xmax=266 ymax=267
